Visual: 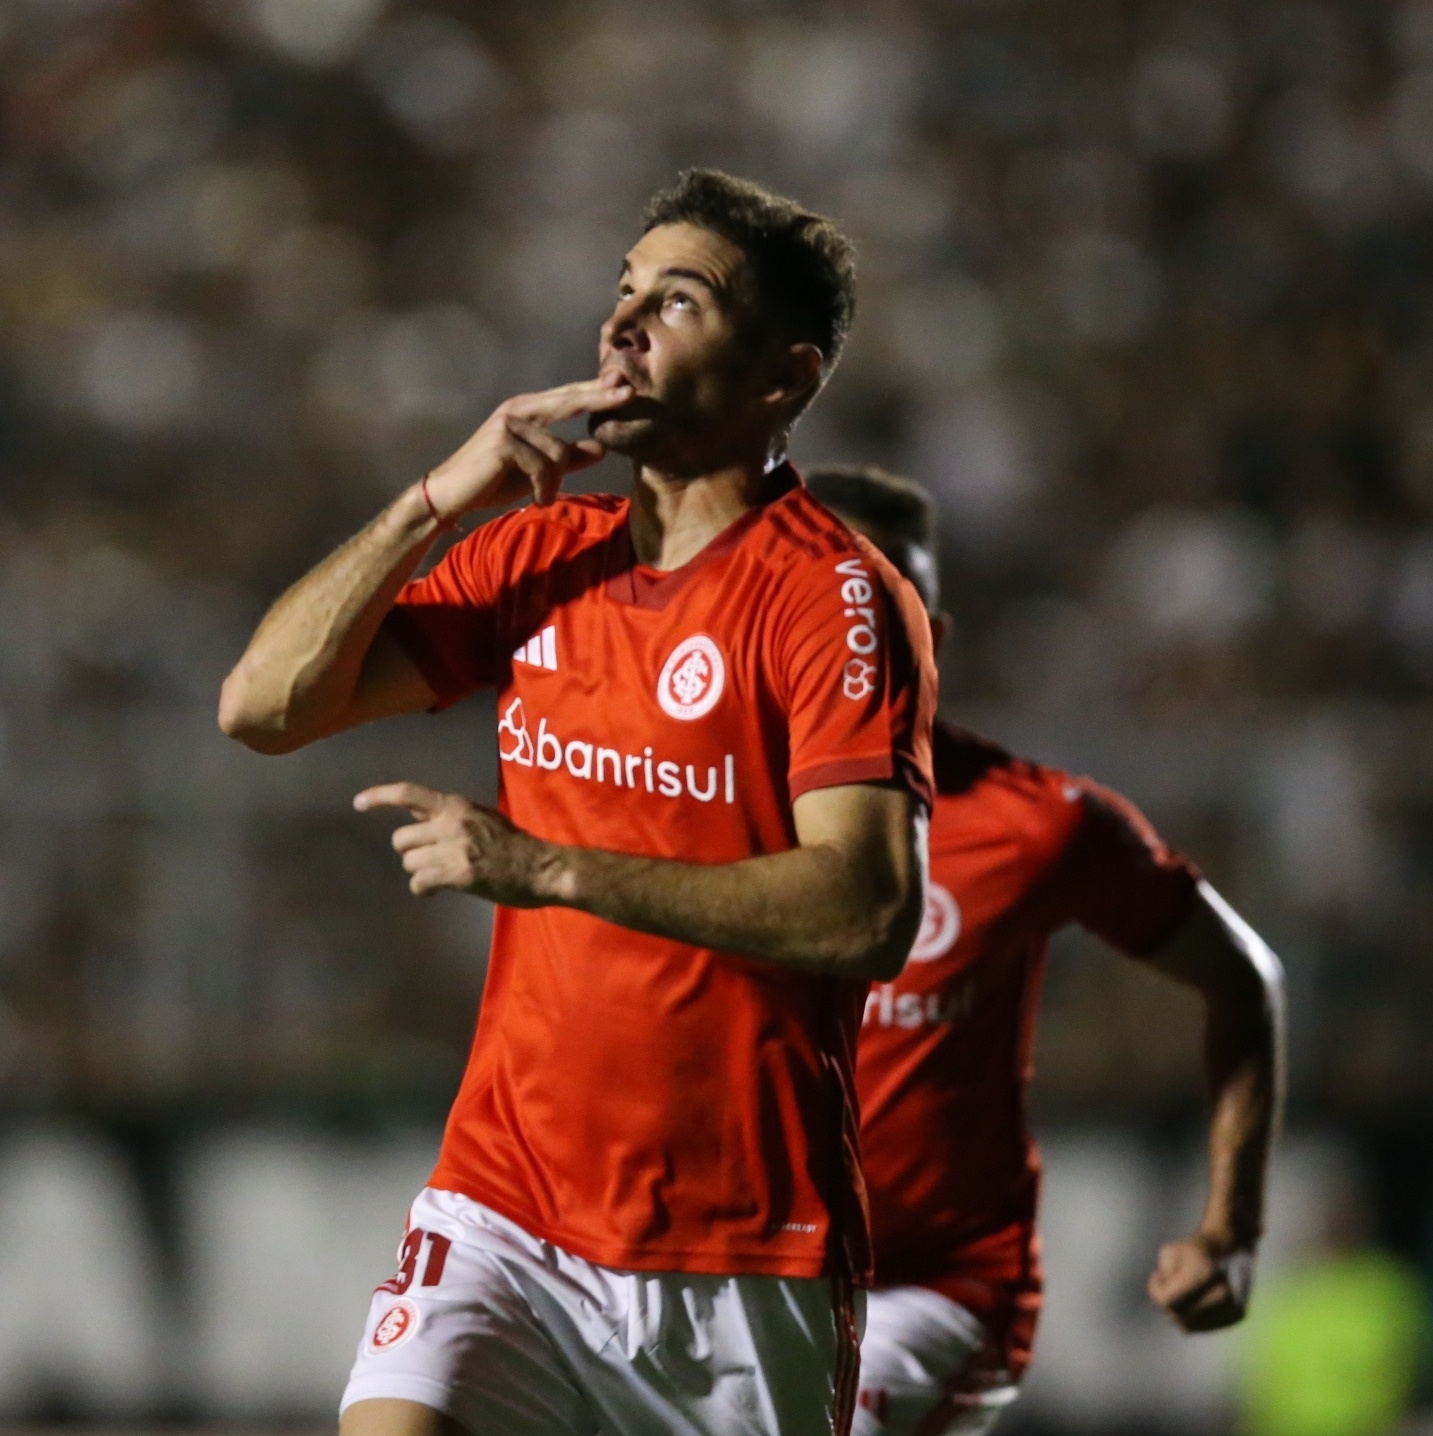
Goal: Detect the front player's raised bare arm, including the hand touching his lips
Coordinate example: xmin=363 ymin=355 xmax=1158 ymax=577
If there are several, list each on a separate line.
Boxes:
xmin=218 ymin=378 xmax=632 ymax=754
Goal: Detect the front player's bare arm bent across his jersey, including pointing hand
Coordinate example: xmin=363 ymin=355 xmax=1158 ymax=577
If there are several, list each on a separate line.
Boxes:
xmin=355 ymin=783 xmax=925 ymax=978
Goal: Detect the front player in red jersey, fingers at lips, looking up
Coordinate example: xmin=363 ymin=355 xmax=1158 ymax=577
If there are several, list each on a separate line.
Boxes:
xmin=220 ymin=171 xmax=935 ymax=1436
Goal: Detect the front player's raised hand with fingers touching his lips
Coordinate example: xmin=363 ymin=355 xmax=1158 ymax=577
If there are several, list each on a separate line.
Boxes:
xmin=428 ymin=373 xmax=632 ymax=518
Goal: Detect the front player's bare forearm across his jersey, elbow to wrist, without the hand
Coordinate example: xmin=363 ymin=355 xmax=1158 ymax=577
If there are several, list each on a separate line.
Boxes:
xmin=546 ymin=846 xmax=923 ymax=978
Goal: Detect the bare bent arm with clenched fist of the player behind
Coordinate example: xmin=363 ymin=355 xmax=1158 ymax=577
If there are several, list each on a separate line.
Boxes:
xmin=1147 ymin=882 xmax=1284 ymax=1331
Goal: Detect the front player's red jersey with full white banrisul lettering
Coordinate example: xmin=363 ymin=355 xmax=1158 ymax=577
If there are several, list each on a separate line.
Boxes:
xmin=389 ymin=468 xmax=936 ymax=1278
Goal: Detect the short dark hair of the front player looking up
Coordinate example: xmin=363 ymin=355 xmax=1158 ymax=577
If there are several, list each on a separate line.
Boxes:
xmin=642 ymin=169 xmax=856 ymax=387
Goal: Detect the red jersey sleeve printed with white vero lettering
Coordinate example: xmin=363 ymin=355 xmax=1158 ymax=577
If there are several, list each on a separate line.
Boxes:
xmin=774 ymin=546 xmax=936 ymax=808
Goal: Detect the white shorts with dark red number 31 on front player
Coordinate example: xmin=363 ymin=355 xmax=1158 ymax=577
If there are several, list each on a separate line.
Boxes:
xmin=339 ymin=1188 xmax=863 ymax=1436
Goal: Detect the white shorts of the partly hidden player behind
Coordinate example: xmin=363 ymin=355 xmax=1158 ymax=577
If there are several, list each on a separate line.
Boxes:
xmin=851 ymin=1287 xmax=1017 ymax=1436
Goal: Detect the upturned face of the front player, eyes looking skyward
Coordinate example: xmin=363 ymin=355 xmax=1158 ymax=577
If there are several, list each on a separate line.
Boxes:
xmin=589 ymin=224 xmax=778 ymax=474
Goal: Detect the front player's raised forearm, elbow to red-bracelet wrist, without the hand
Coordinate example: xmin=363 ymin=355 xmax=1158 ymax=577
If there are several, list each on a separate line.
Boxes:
xmin=218 ymin=488 xmax=438 ymax=752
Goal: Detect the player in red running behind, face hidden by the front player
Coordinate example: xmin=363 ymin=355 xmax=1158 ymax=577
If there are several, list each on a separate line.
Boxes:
xmin=808 ymin=468 xmax=1284 ymax=1436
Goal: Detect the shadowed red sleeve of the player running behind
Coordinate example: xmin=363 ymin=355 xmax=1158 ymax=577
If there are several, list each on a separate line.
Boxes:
xmin=1060 ymin=778 xmax=1200 ymax=958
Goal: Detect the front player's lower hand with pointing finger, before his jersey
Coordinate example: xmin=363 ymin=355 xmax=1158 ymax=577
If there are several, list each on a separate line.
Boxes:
xmin=353 ymin=783 xmax=556 ymax=908
